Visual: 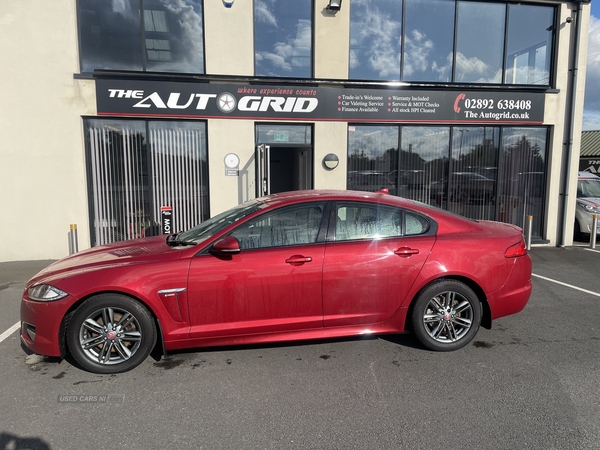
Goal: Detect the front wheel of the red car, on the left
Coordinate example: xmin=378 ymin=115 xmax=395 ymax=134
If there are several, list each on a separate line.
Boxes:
xmin=67 ymin=294 xmax=157 ymax=374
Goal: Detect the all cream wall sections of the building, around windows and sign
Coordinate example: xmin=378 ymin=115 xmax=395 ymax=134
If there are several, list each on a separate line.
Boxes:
xmin=0 ymin=0 xmax=590 ymax=261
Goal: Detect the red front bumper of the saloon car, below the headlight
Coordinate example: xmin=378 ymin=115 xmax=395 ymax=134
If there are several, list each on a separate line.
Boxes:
xmin=20 ymin=294 xmax=73 ymax=356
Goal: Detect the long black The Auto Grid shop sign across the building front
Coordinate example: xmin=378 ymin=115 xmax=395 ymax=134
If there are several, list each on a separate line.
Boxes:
xmin=96 ymin=79 xmax=545 ymax=124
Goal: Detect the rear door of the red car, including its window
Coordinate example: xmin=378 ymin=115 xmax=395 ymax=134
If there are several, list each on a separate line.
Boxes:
xmin=323 ymin=202 xmax=435 ymax=328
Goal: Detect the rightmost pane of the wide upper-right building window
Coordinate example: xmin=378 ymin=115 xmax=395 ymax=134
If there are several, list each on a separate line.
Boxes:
xmin=505 ymin=5 xmax=554 ymax=85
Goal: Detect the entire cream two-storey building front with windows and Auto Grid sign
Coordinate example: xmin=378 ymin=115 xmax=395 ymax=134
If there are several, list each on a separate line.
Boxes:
xmin=0 ymin=0 xmax=590 ymax=261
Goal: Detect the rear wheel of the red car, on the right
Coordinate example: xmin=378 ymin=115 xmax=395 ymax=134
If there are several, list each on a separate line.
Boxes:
xmin=411 ymin=280 xmax=481 ymax=352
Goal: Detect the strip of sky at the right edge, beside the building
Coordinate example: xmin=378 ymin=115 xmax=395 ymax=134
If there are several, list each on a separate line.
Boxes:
xmin=583 ymin=0 xmax=600 ymax=130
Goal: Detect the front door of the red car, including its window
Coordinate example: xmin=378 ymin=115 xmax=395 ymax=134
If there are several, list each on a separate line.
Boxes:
xmin=188 ymin=202 xmax=326 ymax=338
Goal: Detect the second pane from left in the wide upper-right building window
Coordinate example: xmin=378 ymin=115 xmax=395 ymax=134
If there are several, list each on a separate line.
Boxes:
xmin=402 ymin=0 xmax=455 ymax=82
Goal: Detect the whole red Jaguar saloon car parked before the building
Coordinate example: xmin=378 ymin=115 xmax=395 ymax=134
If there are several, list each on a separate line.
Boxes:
xmin=21 ymin=190 xmax=531 ymax=374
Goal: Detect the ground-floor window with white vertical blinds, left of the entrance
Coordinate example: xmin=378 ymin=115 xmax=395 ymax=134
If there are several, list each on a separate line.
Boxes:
xmin=85 ymin=119 xmax=209 ymax=246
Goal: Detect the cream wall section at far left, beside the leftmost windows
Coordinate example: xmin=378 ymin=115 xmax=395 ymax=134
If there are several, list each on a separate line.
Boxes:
xmin=0 ymin=0 xmax=96 ymax=261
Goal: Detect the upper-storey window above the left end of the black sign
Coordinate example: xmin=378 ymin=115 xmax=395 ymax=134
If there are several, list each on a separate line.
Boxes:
xmin=78 ymin=0 xmax=204 ymax=73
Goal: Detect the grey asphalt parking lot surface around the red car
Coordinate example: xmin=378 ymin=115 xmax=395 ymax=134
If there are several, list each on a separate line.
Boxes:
xmin=0 ymin=246 xmax=600 ymax=450
